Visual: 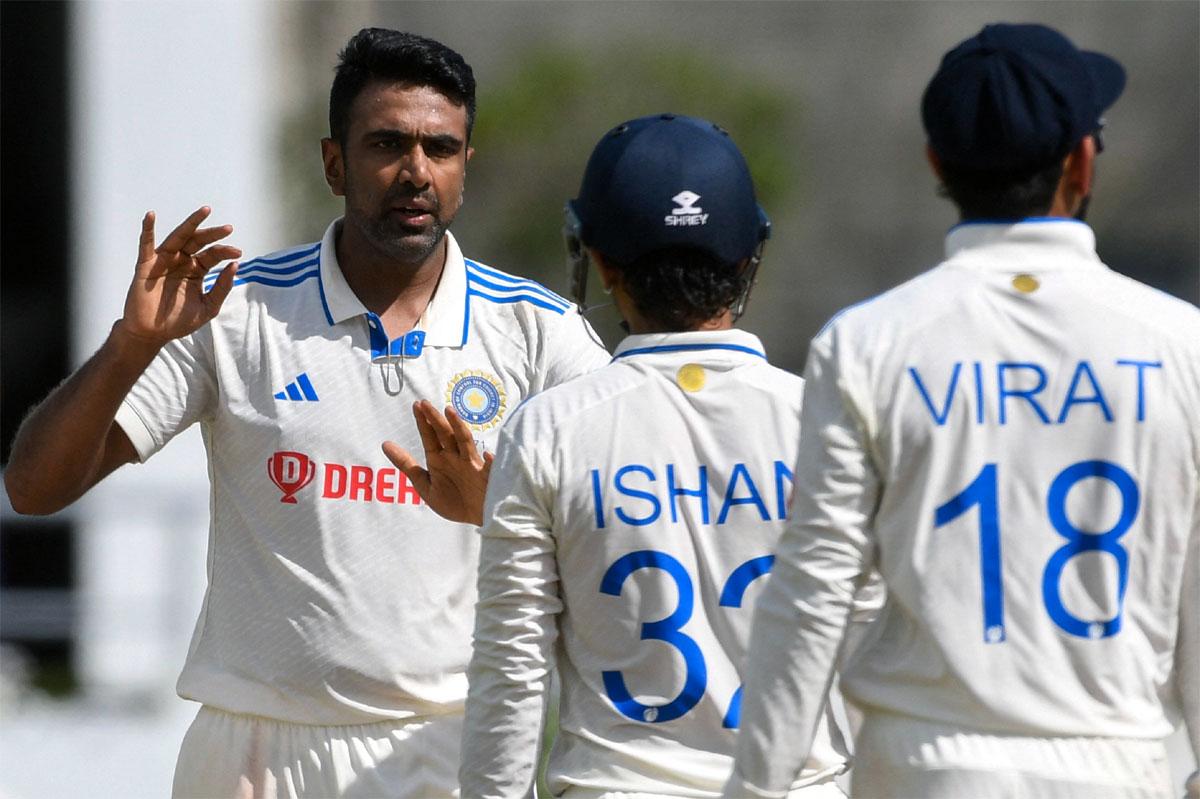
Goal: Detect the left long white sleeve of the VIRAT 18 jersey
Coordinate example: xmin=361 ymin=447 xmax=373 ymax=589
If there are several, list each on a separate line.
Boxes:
xmin=725 ymin=326 xmax=882 ymax=798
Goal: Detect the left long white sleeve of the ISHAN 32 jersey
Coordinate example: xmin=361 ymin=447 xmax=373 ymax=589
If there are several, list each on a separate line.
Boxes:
xmin=458 ymin=410 xmax=562 ymax=799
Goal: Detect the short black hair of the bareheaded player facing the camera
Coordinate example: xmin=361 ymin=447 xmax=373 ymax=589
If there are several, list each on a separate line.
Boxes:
xmin=329 ymin=28 xmax=475 ymax=148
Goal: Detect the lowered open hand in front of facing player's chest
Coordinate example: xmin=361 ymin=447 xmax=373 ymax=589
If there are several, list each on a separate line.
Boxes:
xmin=383 ymin=400 xmax=494 ymax=525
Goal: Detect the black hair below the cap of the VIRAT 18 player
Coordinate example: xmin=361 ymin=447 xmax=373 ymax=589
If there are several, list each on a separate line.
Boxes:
xmin=942 ymin=161 xmax=1063 ymax=220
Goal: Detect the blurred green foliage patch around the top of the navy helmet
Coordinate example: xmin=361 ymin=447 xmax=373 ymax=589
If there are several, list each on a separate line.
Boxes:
xmin=468 ymin=41 xmax=798 ymax=271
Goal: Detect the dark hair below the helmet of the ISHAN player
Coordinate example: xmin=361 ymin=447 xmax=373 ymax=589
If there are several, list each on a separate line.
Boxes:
xmin=610 ymin=247 xmax=750 ymax=332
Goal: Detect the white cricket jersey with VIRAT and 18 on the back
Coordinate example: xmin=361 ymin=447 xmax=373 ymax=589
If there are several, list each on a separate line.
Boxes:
xmin=730 ymin=220 xmax=1200 ymax=795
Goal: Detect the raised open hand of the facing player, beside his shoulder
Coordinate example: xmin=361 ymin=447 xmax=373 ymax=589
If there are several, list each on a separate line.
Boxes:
xmin=121 ymin=205 xmax=241 ymax=344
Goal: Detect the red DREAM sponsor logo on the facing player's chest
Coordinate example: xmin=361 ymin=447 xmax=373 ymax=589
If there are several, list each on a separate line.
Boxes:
xmin=266 ymin=450 xmax=421 ymax=505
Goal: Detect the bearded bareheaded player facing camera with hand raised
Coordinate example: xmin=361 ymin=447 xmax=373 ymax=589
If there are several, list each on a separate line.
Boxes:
xmin=5 ymin=29 xmax=608 ymax=799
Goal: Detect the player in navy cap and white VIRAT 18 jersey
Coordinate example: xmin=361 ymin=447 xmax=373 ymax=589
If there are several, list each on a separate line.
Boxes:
xmin=727 ymin=25 xmax=1200 ymax=799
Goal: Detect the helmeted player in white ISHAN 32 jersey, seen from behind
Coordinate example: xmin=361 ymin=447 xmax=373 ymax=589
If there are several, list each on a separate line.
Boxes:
xmin=461 ymin=114 xmax=864 ymax=799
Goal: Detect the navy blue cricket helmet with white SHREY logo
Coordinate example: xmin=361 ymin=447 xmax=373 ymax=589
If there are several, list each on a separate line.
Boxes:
xmin=568 ymin=114 xmax=770 ymax=264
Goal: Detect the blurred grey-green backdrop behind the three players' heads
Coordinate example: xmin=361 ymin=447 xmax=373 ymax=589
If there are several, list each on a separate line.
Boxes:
xmin=280 ymin=0 xmax=1200 ymax=372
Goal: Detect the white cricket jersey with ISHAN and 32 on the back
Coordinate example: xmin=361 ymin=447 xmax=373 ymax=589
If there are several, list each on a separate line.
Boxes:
xmin=460 ymin=330 xmax=845 ymax=799
